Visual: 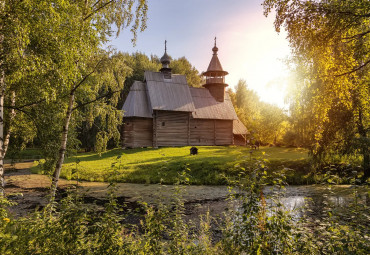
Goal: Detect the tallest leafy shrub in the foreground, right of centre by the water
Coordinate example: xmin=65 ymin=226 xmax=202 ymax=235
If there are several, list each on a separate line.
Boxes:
xmin=222 ymin=161 xmax=304 ymax=254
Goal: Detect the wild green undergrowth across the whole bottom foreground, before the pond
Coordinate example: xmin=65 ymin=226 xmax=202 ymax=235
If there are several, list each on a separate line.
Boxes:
xmin=0 ymin=159 xmax=370 ymax=254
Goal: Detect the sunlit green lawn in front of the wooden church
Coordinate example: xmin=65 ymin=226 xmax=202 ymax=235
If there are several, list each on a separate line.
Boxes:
xmin=33 ymin=146 xmax=308 ymax=185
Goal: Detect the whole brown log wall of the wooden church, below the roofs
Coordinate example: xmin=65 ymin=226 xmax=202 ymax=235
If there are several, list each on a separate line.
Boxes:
xmin=122 ymin=111 xmax=234 ymax=148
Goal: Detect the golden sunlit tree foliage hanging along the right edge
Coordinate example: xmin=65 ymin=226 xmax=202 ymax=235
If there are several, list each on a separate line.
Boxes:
xmin=263 ymin=0 xmax=370 ymax=179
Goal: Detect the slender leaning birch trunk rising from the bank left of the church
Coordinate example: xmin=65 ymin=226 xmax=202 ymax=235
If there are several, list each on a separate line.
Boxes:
xmin=51 ymin=90 xmax=75 ymax=199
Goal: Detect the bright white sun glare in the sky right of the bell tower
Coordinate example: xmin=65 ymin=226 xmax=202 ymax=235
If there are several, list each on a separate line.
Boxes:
xmin=220 ymin=9 xmax=290 ymax=107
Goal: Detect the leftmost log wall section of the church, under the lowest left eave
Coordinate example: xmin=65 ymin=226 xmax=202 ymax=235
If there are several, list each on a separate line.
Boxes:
xmin=122 ymin=118 xmax=153 ymax=148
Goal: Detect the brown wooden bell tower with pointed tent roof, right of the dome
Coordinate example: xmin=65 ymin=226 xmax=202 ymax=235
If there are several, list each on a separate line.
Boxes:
xmin=203 ymin=37 xmax=229 ymax=102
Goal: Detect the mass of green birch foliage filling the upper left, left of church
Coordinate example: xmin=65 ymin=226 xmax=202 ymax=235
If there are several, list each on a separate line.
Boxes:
xmin=0 ymin=0 xmax=147 ymax=196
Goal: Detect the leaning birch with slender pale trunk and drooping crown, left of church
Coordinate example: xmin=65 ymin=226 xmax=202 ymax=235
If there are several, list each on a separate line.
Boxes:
xmin=51 ymin=0 xmax=147 ymax=197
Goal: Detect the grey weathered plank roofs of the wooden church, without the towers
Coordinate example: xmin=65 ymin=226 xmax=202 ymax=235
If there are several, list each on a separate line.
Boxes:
xmin=122 ymin=71 xmax=238 ymax=120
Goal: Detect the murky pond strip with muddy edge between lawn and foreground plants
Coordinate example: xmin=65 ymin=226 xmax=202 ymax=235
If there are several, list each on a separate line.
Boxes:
xmin=5 ymin=162 xmax=370 ymax=218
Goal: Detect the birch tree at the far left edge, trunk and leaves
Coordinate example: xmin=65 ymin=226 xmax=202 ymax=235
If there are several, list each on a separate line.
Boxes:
xmin=0 ymin=0 xmax=42 ymax=196
